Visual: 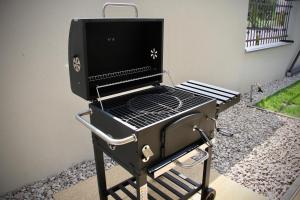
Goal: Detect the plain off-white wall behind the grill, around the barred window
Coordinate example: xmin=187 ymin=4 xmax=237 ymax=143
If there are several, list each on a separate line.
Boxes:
xmin=0 ymin=0 xmax=300 ymax=194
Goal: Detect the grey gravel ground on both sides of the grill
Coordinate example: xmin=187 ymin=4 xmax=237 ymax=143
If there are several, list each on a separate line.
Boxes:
xmin=0 ymin=75 xmax=300 ymax=200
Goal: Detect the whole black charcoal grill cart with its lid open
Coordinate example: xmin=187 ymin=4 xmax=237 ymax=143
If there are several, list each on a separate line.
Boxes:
xmin=69 ymin=3 xmax=239 ymax=199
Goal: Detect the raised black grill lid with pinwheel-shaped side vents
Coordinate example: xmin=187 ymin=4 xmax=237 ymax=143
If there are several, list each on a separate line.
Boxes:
xmin=69 ymin=19 xmax=163 ymax=100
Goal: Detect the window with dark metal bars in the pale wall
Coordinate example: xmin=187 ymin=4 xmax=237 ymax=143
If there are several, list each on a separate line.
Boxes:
xmin=245 ymin=0 xmax=292 ymax=47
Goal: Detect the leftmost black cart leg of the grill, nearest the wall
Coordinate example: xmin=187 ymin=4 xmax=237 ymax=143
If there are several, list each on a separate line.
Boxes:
xmin=94 ymin=144 xmax=107 ymax=200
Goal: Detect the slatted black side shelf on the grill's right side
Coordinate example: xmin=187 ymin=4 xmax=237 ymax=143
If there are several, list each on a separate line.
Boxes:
xmin=176 ymin=80 xmax=241 ymax=116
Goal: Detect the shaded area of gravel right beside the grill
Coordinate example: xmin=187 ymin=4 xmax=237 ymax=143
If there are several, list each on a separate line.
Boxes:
xmin=213 ymin=101 xmax=284 ymax=174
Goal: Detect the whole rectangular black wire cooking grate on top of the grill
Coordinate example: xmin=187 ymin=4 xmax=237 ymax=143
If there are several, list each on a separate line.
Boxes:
xmin=105 ymin=87 xmax=211 ymax=128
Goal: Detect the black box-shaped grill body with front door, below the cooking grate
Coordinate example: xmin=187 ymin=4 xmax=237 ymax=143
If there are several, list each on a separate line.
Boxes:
xmin=90 ymin=86 xmax=216 ymax=174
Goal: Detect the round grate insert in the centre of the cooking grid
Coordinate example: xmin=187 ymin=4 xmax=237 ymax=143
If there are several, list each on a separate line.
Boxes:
xmin=127 ymin=94 xmax=182 ymax=114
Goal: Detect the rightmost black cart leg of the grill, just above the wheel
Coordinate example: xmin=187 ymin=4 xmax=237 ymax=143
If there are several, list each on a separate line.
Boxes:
xmin=201 ymin=147 xmax=212 ymax=200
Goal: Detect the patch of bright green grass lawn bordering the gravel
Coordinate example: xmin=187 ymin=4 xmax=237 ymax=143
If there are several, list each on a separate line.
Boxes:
xmin=256 ymin=81 xmax=300 ymax=118
